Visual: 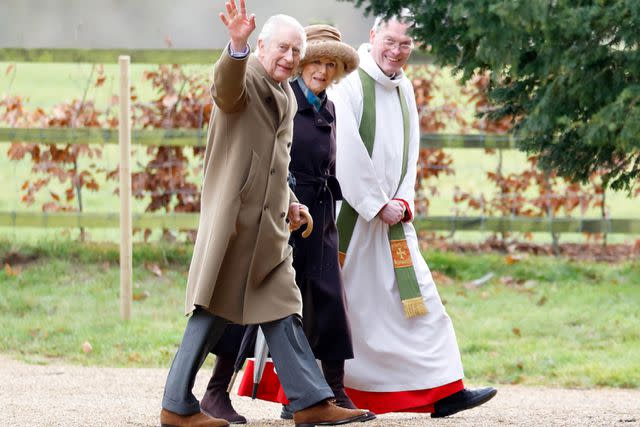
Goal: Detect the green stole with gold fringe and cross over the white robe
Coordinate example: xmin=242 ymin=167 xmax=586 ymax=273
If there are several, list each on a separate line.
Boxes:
xmin=336 ymin=68 xmax=427 ymax=317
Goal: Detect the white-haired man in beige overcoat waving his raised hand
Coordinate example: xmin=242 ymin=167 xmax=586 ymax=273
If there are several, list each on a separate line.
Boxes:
xmin=160 ymin=0 xmax=370 ymax=427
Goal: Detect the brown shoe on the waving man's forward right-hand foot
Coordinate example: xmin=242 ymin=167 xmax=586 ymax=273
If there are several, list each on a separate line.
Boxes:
xmin=293 ymin=400 xmax=375 ymax=427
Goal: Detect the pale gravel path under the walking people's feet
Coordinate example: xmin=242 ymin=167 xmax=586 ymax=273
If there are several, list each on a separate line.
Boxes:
xmin=0 ymin=355 xmax=640 ymax=427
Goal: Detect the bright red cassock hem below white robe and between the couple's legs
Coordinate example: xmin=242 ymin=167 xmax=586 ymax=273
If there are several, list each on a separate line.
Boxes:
xmin=238 ymin=359 xmax=464 ymax=414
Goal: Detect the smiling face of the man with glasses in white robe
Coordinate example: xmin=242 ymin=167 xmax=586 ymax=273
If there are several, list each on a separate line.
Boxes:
xmin=369 ymin=19 xmax=413 ymax=76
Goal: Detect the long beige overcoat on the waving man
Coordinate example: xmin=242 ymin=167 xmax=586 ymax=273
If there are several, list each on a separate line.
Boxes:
xmin=186 ymin=52 xmax=302 ymax=324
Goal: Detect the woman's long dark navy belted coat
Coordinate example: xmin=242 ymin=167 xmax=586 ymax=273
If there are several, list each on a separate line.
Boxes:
xmin=289 ymin=81 xmax=353 ymax=360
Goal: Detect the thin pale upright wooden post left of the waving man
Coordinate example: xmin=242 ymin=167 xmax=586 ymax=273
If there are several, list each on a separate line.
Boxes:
xmin=118 ymin=56 xmax=133 ymax=320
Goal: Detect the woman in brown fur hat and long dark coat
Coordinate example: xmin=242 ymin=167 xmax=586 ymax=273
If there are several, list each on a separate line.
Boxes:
xmin=283 ymin=25 xmax=359 ymax=416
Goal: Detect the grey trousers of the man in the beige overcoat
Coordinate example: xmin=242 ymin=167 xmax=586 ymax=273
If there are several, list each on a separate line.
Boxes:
xmin=162 ymin=308 xmax=333 ymax=415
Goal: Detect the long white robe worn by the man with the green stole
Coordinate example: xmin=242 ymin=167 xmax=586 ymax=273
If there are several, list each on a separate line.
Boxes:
xmin=329 ymin=45 xmax=464 ymax=392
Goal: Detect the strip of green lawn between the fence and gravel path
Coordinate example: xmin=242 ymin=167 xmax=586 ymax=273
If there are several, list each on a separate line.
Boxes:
xmin=0 ymin=240 xmax=640 ymax=388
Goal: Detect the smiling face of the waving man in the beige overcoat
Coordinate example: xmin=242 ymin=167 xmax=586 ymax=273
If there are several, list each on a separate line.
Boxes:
xmin=258 ymin=25 xmax=302 ymax=83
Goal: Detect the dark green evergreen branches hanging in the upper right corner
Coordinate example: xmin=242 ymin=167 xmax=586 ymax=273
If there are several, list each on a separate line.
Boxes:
xmin=350 ymin=0 xmax=640 ymax=190
